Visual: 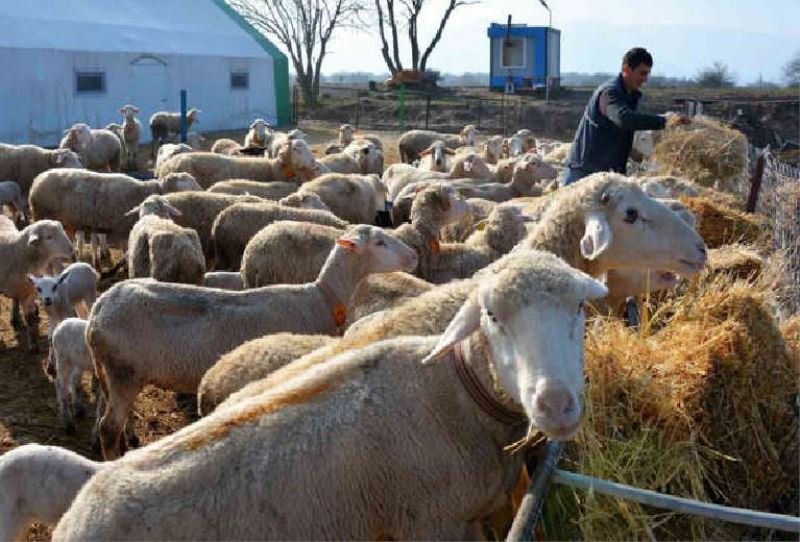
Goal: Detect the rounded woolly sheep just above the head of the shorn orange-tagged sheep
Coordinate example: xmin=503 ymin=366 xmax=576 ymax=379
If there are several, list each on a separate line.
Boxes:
xmin=299 ymin=173 xmax=386 ymax=224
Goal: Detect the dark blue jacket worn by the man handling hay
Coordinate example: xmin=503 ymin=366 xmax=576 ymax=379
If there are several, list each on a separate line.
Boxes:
xmin=567 ymin=75 xmax=666 ymax=175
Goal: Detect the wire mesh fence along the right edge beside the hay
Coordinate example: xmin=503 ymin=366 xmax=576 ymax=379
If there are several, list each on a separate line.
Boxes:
xmin=750 ymin=147 xmax=800 ymax=317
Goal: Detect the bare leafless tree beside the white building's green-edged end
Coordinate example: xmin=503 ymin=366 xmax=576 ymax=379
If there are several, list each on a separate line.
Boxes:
xmin=228 ymin=0 xmax=368 ymax=106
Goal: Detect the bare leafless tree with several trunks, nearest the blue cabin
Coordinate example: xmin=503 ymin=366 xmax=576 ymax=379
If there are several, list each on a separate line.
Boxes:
xmin=374 ymin=0 xmax=477 ymax=75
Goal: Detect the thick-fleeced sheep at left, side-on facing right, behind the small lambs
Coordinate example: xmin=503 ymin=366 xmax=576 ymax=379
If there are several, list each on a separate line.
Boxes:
xmin=29 ymin=169 xmax=200 ymax=253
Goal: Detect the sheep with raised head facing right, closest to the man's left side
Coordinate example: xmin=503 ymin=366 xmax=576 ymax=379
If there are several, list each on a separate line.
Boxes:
xmin=451 ymin=153 xmax=558 ymax=202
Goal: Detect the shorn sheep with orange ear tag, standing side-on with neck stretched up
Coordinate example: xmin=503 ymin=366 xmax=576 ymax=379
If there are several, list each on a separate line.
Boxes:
xmin=86 ymin=225 xmax=417 ymax=459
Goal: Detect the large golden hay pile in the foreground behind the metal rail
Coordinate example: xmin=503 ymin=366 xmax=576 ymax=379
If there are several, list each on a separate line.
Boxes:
xmin=545 ymin=276 xmax=800 ymax=540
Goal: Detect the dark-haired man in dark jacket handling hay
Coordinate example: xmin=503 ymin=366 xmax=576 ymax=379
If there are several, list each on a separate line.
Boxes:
xmin=561 ymin=47 xmax=689 ymax=186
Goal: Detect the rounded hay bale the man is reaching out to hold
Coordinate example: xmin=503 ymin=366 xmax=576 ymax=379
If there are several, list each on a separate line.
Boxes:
xmin=652 ymin=117 xmax=748 ymax=193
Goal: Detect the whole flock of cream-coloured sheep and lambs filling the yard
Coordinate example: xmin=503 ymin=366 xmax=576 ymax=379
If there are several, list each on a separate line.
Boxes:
xmin=0 ymin=105 xmax=707 ymax=540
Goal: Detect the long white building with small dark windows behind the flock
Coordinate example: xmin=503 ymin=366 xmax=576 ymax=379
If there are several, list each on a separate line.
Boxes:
xmin=0 ymin=0 xmax=290 ymax=146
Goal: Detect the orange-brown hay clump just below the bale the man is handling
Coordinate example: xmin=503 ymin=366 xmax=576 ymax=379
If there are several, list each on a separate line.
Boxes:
xmin=681 ymin=196 xmax=766 ymax=248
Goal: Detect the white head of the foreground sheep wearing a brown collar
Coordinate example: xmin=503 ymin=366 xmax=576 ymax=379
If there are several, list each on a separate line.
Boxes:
xmin=423 ymin=250 xmax=607 ymax=440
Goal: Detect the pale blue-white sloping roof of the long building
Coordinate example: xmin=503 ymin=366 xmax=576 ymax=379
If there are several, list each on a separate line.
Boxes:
xmin=0 ymin=0 xmax=275 ymax=57
